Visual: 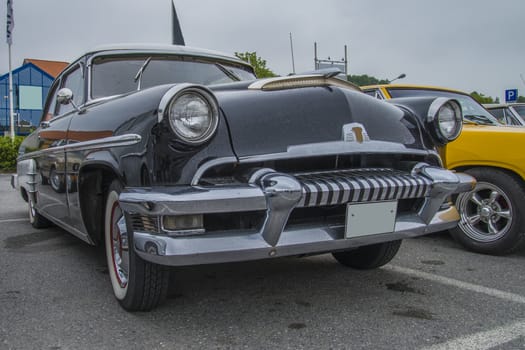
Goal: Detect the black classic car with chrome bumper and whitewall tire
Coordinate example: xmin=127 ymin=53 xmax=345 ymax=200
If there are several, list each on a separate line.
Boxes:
xmin=12 ymin=46 xmax=475 ymax=310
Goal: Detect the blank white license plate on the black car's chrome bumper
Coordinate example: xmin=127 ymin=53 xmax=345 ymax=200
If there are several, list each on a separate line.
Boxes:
xmin=345 ymin=201 xmax=397 ymax=238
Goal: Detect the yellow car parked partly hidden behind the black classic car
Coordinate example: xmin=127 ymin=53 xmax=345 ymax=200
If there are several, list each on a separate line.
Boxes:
xmin=362 ymin=85 xmax=525 ymax=255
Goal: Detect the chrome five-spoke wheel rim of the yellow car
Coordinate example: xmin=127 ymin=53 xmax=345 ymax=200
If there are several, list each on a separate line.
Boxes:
xmin=456 ymin=182 xmax=514 ymax=243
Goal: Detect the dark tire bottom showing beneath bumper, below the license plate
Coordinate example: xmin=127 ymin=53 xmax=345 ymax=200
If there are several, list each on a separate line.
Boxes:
xmin=332 ymin=240 xmax=401 ymax=270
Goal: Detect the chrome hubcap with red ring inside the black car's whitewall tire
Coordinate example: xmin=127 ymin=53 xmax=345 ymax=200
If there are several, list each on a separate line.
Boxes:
xmin=109 ymin=202 xmax=129 ymax=288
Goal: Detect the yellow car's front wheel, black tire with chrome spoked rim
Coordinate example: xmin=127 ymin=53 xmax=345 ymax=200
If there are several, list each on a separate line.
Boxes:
xmin=450 ymin=167 xmax=525 ymax=255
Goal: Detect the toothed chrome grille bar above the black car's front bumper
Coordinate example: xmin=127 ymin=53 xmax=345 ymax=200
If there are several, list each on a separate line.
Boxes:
xmin=294 ymin=168 xmax=432 ymax=207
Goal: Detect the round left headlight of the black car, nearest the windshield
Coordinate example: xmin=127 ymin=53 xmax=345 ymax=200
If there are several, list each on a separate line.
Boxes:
xmin=167 ymin=88 xmax=219 ymax=144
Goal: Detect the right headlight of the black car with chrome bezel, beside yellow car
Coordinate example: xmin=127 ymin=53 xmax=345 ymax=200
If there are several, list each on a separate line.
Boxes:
xmin=427 ymin=97 xmax=463 ymax=146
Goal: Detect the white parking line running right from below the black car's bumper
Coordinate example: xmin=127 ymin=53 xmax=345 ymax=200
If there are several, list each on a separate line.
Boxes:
xmin=383 ymin=265 xmax=525 ymax=304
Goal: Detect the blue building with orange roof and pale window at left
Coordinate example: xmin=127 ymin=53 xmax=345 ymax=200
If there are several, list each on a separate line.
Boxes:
xmin=0 ymin=59 xmax=67 ymax=133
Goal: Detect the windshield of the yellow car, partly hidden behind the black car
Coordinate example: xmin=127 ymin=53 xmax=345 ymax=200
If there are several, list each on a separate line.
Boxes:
xmin=387 ymin=88 xmax=500 ymax=125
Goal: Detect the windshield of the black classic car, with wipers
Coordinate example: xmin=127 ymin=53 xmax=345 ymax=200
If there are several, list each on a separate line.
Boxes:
xmin=91 ymin=56 xmax=255 ymax=99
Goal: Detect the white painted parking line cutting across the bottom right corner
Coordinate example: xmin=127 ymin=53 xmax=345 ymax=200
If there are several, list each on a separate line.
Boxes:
xmin=422 ymin=320 xmax=525 ymax=350
